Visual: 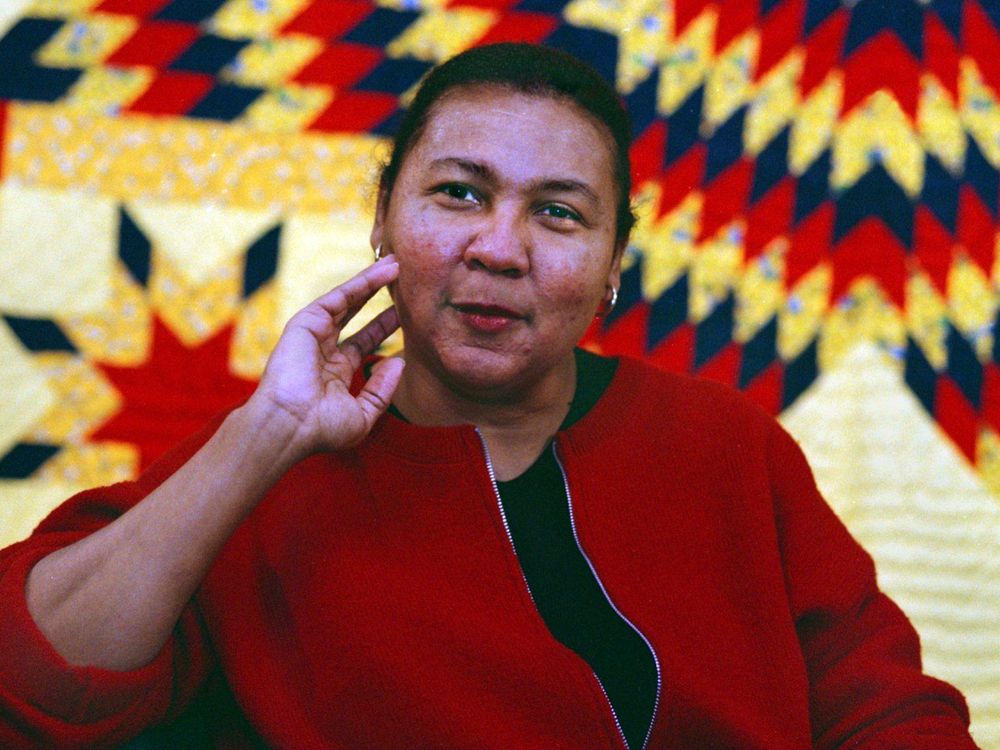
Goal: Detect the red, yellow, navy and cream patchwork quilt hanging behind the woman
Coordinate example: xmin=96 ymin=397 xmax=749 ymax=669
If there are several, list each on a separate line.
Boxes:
xmin=0 ymin=0 xmax=1000 ymax=749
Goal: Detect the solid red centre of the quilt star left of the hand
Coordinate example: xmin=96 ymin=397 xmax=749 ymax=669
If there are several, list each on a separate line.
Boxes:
xmin=90 ymin=318 xmax=256 ymax=471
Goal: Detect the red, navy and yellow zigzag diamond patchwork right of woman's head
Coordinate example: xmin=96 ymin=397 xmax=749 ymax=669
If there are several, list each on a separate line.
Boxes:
xmin=590 ymin=0 xmax=1000 ymax=488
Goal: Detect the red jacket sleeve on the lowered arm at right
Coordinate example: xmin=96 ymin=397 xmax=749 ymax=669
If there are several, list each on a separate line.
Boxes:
xmin=770 ymin=425 xmax=976 ymax=750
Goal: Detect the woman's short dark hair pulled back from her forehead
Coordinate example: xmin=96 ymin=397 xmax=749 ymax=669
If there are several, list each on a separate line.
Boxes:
xmin=379 ymin=42 xmax=635 ymax=243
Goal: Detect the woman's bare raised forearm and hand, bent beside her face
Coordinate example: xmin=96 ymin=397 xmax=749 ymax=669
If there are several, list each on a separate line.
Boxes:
xmin=26 ymin=258 xmax=402 ymax=670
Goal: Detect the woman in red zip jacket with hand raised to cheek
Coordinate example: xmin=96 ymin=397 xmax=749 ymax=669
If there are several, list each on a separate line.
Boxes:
xmin=0 ymin=45 xmax=974 ymax=749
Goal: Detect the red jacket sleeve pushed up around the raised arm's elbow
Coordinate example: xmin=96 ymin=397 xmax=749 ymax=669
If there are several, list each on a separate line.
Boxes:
xmin=0 ymin=418 xmax=221 ymax=750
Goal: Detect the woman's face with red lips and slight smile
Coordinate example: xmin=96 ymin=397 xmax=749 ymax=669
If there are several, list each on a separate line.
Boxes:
xmin=372 ymin=87 xmax=620 ymax=396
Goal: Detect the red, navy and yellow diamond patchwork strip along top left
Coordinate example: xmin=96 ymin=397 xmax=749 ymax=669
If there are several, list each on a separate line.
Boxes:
xmin=0 ymin=0 xmax=617 ymax=134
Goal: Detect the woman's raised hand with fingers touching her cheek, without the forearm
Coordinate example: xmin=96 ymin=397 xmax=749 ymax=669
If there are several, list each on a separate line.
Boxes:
xmin=247 ymin=256 xmax=403 ymax=458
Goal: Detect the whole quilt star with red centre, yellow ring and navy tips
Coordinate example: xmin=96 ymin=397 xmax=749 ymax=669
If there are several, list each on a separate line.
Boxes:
xmin=0 ymin=206 xmax=281 ymax=484
